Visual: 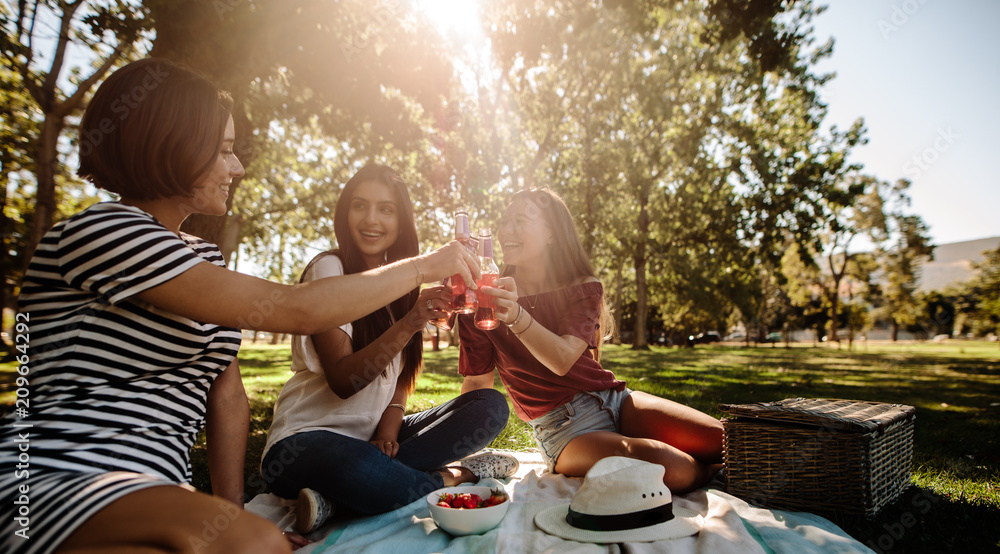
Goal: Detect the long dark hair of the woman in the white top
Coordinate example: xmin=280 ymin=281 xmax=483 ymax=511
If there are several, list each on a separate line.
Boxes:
xmin=302 ymin=164 xmax=423 ymax=392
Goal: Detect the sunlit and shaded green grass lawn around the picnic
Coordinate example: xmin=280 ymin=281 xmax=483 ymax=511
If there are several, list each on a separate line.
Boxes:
xmin=0 ymin=342 xmax=1000 ymax=553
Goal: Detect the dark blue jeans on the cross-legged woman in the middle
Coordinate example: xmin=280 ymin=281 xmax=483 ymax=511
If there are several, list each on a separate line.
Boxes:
xmin=261 ymin=389 xmax=510 ymax=514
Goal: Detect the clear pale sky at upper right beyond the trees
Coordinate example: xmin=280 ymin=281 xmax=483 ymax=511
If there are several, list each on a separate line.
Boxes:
xmin=813 ymin=0 xmax=1000 ymax=244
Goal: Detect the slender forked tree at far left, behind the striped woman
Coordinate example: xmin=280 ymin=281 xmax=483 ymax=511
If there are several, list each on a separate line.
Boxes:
xmin=0 ymin=0 xmax=149 ymax=263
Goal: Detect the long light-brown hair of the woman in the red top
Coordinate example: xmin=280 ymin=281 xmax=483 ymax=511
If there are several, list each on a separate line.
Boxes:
xmin=500 ymin=188 xmax=614 ymax=358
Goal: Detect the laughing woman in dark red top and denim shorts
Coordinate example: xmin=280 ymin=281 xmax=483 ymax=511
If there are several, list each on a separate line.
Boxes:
xmin=459 ymin=189 xmax=723 ymax=492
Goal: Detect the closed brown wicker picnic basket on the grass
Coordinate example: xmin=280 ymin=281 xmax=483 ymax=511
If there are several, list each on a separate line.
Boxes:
xmin=719 ymin=398 xmax=916 ymax=517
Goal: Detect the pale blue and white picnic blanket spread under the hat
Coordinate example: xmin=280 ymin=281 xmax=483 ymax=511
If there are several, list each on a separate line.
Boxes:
xmin=246 ymin=452 xmax=872 ymax=554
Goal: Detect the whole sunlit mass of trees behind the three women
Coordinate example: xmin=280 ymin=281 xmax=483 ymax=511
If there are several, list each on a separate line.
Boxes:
xmin=0 ymin=0 xmax=989 ymax=348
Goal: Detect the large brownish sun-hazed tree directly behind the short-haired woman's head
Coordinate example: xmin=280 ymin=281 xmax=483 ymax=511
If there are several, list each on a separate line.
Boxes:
xmin=144 ymin=0 xmax=452 ymax=259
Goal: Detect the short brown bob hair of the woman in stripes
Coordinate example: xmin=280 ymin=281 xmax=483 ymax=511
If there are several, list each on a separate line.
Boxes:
xmin=77 ymin=58 xmax=233 ymax=200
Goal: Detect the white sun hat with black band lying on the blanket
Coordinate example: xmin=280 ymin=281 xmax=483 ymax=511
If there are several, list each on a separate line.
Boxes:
xmin=535 ymin=456 xmax=703 ymax=543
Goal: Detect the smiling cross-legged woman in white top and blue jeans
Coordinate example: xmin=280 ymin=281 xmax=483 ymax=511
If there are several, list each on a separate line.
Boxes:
xmin=261 ymin=165 xmax=517 ymax=532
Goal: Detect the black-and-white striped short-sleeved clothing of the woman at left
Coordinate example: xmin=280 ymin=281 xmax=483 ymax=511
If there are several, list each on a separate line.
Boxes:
xmin=0 ymin=202 xmax=240 ymax=551
